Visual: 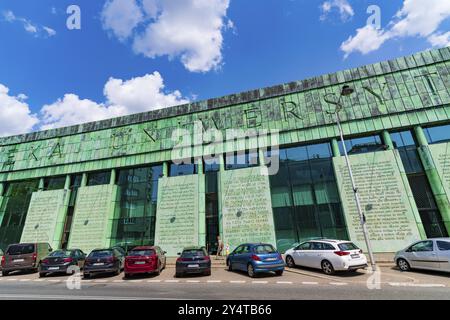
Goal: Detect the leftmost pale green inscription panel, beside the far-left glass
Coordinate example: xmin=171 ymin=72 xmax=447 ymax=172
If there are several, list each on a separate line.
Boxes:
xmin=20 ymin=190 xmax=67 ymax=248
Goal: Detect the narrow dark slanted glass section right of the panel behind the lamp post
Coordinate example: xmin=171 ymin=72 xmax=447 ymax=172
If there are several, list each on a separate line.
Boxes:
xmin=391 ymin=131 xmax=448 ymax=238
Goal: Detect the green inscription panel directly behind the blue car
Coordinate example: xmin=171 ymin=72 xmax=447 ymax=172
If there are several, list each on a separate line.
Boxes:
xmin=220 ymin=167 xmax=276 ymax=250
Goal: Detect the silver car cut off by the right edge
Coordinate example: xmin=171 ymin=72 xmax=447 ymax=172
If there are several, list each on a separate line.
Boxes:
xmin=394 ymin=238 xmax=450 ymax=272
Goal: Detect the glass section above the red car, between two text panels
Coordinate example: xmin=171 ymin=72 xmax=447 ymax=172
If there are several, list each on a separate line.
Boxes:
xmin=112 ymin=165 xmax=162 ymax=247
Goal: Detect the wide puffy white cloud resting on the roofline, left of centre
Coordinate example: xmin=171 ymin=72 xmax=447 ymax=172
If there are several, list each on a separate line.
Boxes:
xmin=41 ymin=72 xmax=189 ymax=130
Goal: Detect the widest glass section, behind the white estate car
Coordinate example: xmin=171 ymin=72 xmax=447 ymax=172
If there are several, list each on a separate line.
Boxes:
xmin=270 ymin=143 xmax=348 ymax=252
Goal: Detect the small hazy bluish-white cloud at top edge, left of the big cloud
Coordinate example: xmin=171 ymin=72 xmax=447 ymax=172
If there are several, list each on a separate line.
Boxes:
xmin=101 ymin=0 xmax=144 ymax=41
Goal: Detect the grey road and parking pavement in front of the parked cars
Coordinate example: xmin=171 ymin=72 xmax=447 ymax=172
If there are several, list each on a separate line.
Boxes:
xmin=0 ymin=263 xmax=450 ymax=300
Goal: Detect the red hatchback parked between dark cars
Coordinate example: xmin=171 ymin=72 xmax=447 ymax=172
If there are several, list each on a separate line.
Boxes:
xmin=125 ymin=246 xmax=166 ymax=278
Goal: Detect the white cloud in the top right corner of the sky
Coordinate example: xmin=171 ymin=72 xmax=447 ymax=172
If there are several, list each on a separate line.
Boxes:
xmin=341 ymin=0 xmax=450 ymax=57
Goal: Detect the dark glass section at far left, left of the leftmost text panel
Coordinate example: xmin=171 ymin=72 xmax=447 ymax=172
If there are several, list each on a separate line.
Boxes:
xmin=0 ymin=179 xmax=39 ymax=250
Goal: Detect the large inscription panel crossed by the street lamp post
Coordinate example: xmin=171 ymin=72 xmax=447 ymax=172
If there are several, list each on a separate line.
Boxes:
xmin=333 ymin=151 xmax=420 ymax=253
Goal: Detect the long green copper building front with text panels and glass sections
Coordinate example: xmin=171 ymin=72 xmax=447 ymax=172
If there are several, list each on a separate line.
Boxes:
xmin=0 ymin=48 xmax=450 ymax=255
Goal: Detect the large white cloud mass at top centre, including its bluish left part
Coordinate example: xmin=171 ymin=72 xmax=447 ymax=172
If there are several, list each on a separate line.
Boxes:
xmin=102 ymin=0 xmax=232 ymax=72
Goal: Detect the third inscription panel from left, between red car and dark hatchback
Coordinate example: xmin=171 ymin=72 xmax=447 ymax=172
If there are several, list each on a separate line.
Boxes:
xmin=155 ymin=175 xmax=199 ymax=256
